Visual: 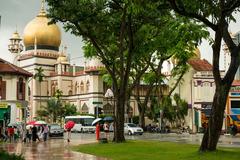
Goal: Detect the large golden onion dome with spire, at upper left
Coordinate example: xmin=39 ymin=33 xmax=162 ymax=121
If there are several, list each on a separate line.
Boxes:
xmin=23 ymin=7 xmax=61 ymax=49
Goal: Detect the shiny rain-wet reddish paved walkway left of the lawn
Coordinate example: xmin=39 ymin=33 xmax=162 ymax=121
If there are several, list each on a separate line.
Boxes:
xmin=0 ymin=135 xmax=106 ymax=160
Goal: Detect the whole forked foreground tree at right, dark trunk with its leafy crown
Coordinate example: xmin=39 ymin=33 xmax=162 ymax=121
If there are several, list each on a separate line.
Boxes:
xmin=168 ymin=0 xmax=240 ymax=151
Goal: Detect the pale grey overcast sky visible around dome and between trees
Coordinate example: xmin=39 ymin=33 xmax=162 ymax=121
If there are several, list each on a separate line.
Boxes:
xmin=0 ymin=0 xmax=240 ymax=68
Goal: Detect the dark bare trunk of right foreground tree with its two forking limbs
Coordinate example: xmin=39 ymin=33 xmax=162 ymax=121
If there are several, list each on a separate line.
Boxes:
xmin=199 ymin=20 xmax=240 ymax=152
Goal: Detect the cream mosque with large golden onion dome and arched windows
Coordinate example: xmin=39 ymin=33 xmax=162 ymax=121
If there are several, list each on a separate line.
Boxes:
xmin=7 ymin=4 xmax=119 ymax=120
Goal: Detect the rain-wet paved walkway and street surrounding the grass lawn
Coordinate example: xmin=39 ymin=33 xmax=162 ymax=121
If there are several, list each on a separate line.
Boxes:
xmin=0 ymin=133 xmax=240 ymax=160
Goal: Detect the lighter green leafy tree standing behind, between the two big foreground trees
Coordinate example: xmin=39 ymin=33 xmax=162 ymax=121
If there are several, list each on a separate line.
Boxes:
xmin=130 ymin=15 xmax=209 ymax=127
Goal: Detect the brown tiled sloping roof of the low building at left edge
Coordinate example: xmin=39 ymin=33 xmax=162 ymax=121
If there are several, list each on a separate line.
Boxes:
xmin=0 ymin=58 xmax=33 ymax=77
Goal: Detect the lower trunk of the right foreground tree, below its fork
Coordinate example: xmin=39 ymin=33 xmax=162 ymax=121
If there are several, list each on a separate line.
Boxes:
xmin=199 ymin=84 xmax=231 ymax=151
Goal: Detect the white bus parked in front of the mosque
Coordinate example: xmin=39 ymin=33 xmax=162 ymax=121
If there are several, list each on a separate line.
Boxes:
xmin=65 ymin=115 xmax=96 ymax=133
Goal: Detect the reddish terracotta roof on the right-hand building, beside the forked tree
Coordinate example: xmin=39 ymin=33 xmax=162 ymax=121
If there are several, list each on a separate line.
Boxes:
xmin=188 ymin=59 xmax=212 ymax=71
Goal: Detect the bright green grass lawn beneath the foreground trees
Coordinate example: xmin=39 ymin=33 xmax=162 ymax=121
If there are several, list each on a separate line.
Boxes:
xmin=73 ymin=141 xmax=240 ymax=160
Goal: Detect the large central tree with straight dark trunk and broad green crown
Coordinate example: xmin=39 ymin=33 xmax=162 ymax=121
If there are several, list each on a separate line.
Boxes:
xmin=47 ymin=0 xmax=165 ymax=142
